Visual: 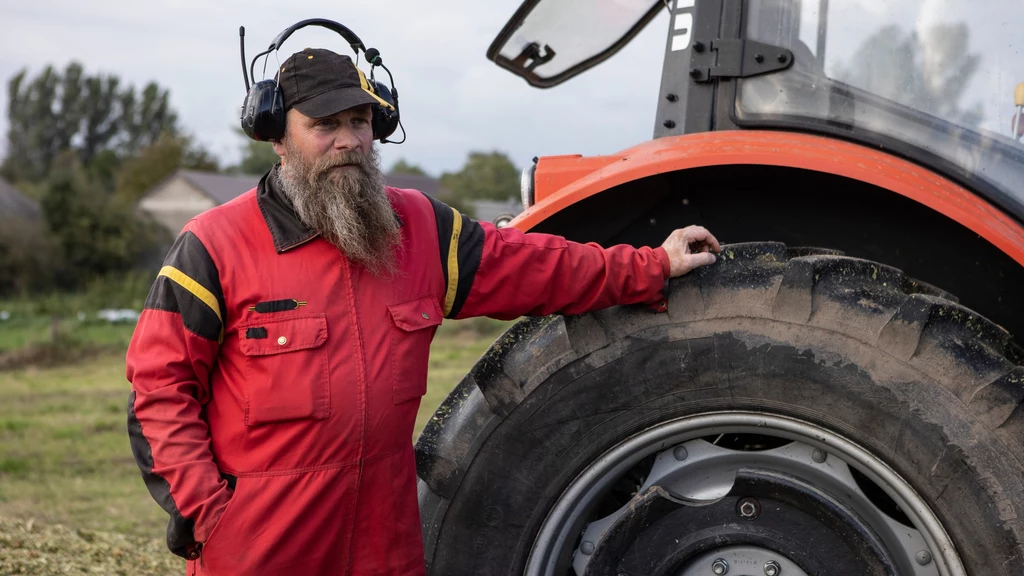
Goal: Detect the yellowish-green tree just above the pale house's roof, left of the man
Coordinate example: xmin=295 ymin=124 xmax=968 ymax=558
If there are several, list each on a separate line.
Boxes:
xmin=116 ymin=134 xmax=218 ymax=204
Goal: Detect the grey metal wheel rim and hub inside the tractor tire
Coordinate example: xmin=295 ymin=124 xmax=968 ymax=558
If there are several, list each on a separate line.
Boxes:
xmin=527 ymin=414 xmax=964 ymax=576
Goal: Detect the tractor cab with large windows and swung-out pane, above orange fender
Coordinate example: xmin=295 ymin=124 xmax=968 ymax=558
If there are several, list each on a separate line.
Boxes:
xmin=487 ymin=0 xmax=1024 ymax=219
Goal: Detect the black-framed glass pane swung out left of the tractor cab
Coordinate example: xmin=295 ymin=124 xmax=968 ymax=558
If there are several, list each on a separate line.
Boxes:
xmin=487 ymin=0 xmax=665 ymax=87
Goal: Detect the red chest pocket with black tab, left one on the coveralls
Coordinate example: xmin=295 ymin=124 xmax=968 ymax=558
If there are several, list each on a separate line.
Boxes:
xmin=239 ymin=314 xmax=331 ymax=426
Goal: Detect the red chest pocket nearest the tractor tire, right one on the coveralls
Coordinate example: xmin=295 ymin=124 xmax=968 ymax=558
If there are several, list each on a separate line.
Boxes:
xmin=388 ymin=296 xmax=441 ymax=404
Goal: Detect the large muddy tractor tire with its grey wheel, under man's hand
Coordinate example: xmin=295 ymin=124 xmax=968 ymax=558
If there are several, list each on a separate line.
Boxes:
xmin=416 ymin=242 xmax=1024 ymax=576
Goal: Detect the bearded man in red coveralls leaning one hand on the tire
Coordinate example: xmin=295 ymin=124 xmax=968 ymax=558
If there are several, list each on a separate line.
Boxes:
xmin=127 ymin=45 xmax=720 ymax=576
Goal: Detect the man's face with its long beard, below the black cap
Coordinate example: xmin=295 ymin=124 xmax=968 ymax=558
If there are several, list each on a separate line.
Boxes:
xmin=273 ymin=106 xmax=400 ymax=277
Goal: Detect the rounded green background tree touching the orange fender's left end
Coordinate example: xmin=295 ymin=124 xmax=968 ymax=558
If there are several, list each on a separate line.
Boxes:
xmin=440 ymin=152 xmax=519 ymax=201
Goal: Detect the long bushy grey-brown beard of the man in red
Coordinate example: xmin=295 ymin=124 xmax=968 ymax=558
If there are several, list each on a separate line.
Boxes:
xmin=276 ymin=141 xmax=401 ymax=278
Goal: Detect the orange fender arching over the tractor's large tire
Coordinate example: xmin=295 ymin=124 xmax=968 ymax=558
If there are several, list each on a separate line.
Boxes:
xmin=509 ymin=130 xmax=1024 ymax=265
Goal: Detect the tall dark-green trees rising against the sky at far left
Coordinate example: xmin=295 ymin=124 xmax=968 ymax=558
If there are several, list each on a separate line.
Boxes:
xmin=0 ymin=61 xmax=177 ymax=182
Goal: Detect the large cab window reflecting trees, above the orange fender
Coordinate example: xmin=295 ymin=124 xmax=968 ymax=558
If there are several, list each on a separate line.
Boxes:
xmin=735 ymin=0 xmax=1024 ymax=217
